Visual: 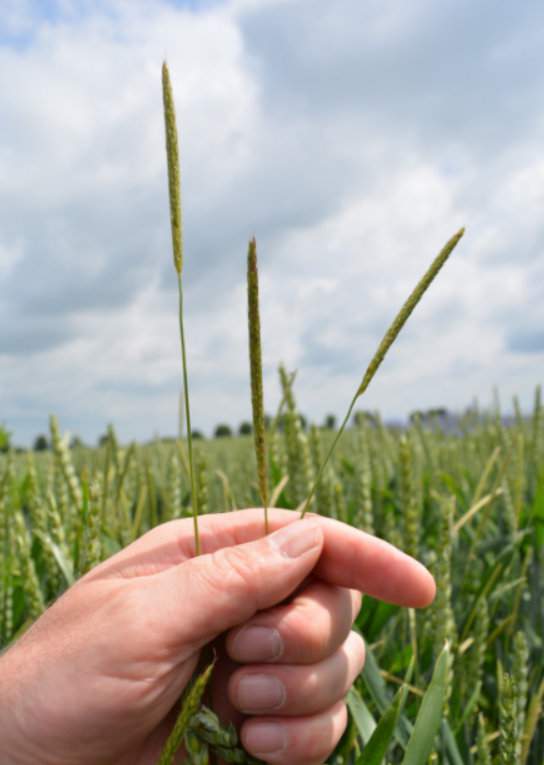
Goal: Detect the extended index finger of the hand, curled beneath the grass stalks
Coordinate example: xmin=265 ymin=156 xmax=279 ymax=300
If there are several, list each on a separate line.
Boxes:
xmin=103 ymin=508 xmax=435 ymax=608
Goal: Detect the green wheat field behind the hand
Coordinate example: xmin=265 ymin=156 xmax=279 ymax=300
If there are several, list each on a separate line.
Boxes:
xmin=0 ymin=390 xmax=544 ymax=765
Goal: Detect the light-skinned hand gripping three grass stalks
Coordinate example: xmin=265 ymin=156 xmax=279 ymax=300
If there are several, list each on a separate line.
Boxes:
xmin=0 ymin=510 xmax=435 ymax=765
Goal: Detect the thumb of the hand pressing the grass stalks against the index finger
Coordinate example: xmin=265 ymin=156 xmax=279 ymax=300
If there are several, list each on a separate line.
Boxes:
xmin=156 ymin=519 xmax=323 ymax=652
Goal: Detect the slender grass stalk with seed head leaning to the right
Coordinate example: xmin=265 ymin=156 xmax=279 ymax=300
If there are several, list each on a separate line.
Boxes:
xmin=300 ymin=228 xmax=465 ymax=518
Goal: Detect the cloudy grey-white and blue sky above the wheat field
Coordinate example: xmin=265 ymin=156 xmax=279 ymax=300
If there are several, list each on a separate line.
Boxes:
xmin=0 ymin=0 xmax=544 ymax=443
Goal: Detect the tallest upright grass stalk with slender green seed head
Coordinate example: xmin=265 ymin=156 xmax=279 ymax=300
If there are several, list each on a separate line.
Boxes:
xmin=162 ymin=61 xmax=200 ymax=555
